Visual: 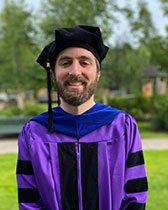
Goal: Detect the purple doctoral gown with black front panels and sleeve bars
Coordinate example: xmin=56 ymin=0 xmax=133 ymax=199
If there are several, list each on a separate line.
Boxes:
xmin=17 ymin=104 xmax=148 ymax=210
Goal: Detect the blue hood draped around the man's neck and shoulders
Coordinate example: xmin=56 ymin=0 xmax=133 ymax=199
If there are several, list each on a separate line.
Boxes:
xmin=30 ymin=103 xmax=123 ymax=138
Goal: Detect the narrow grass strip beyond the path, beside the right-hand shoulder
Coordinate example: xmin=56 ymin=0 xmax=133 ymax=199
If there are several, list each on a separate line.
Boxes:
xmin=137 ymin=122 xmax=168 ymax=138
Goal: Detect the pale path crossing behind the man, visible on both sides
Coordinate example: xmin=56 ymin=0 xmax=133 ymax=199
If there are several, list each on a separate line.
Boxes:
xmin=0 ymin=138 xmax=168 ymax=154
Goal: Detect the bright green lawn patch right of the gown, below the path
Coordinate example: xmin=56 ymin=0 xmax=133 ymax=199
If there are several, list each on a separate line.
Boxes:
xmin=144 ymin=151 xmax=168 ymax=210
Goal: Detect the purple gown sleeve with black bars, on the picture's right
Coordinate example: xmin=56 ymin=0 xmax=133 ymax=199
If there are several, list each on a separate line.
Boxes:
xmin=121 ymin=114 xmax=148 ymax=210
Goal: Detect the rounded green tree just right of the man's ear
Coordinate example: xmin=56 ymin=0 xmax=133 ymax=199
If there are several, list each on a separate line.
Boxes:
xmin=101 ymin=43 xmax=151 ymax=93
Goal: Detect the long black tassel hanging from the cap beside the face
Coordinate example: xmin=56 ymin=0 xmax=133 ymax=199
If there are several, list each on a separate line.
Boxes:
xmin=46 ymin=60 xmax=53 ymax=132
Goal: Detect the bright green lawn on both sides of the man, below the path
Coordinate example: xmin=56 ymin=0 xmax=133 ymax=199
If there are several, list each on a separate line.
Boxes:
xmin=0 ymin=151 xmax=168 ymax=210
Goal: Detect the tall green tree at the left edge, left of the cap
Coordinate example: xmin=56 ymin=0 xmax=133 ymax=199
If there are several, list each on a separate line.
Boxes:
xmin=0 ymin=0 xmax=44 ymax=92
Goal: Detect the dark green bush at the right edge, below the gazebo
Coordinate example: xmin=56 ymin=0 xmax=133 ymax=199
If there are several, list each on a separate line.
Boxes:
xmin=151 ymin=94 xmax=168 ymax=131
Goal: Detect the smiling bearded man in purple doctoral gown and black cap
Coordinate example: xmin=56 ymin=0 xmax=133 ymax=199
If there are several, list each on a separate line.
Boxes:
xmin=17 ymin=26 xmax=147 ymax=210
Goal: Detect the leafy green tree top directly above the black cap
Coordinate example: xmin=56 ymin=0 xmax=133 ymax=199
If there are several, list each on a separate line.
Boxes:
xmin=40 ymin=0 xmax=132 ymax=42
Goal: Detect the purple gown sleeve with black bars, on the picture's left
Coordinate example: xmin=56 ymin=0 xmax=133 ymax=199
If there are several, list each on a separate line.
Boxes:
xmin=16 ymin=123 xmax=47 ymax=210
